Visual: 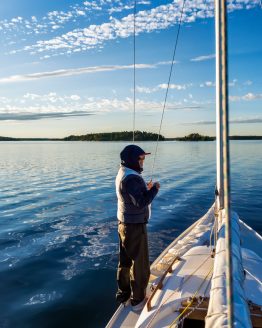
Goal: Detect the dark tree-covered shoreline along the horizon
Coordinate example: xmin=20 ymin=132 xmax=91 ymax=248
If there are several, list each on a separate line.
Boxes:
xmin=0 ymin=131 xmax=262 ymax=142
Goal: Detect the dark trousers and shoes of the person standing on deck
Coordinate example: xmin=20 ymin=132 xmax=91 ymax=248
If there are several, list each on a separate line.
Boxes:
xmin=116 ymin=223 xmax=150 ymax=305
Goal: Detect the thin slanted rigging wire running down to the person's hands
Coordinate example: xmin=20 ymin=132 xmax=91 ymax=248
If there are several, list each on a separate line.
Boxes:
xmin=151 ymin=0 xmax=186 ymax=180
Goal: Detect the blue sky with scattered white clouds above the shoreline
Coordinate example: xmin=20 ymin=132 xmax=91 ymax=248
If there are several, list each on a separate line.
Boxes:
xmin=0 ymin=0 xmax=262 ymax=137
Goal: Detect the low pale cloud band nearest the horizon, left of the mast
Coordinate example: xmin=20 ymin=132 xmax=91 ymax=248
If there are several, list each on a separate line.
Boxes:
xmin=0 ymin=92 xmax=199 ymax=120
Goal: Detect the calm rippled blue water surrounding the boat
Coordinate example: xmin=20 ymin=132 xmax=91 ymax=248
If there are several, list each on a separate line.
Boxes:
xmin=0 ymin=141 xmax=262 ymax=328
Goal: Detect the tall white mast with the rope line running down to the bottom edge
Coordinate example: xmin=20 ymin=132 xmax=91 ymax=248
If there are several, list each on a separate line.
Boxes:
xmin=215 ymin=0 xmax=234 ymax=328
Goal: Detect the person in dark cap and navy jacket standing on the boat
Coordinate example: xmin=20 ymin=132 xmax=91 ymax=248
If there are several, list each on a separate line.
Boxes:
xmin=116 ymin=145 xmax=160 ymax=310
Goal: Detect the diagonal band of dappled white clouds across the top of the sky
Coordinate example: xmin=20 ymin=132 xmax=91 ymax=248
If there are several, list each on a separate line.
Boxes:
xmin=15 ymin=0 xmax=258 ymax=57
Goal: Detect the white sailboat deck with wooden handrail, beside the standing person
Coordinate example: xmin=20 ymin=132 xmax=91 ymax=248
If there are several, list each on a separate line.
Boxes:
xmin=107 ymin=208 xmax=262 ymax=328
